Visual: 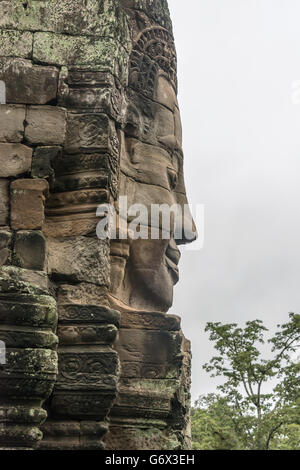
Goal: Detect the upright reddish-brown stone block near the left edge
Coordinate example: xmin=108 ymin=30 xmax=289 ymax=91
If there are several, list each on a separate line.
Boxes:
xmin=10 ymin=179 xmax=48 ymax=230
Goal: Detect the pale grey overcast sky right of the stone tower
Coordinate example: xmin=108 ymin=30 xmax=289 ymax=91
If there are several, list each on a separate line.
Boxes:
xmin=169 ymin=0 xmax=300 ymax=399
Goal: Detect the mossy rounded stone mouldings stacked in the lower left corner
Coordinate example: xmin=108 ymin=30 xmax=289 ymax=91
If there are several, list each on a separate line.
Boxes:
xmin=0 ymin=267 xmax=57 ymax=449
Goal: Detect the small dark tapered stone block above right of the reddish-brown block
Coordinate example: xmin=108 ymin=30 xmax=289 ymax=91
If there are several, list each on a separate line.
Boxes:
xmin=31 ymin=147 xmax=62 ymax=178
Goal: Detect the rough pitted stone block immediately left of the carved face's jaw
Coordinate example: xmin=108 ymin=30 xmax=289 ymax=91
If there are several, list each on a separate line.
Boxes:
xmin=47 ymin=237 xmax=109 ymax=285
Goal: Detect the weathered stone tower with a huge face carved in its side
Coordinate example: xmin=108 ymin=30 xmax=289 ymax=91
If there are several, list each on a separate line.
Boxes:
xmin=0 ymin=0 xmax=193 ymax=450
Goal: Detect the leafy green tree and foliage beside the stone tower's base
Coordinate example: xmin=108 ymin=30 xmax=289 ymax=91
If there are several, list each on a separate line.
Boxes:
xmin=193 ymin=313 xmax=300 ymax=450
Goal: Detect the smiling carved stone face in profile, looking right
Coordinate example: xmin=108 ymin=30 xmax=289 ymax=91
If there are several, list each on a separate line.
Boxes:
xmin=111 ymin=75 xmax=195 ymax=311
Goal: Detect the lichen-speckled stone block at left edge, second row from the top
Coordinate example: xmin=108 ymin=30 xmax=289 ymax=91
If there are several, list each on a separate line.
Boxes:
xmin=0 ymin=30 xmax=33 ymax=59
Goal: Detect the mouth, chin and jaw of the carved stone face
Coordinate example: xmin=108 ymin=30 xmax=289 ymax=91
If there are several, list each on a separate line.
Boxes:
xmin=111 ymin=240 xmax=180 ymax=312
